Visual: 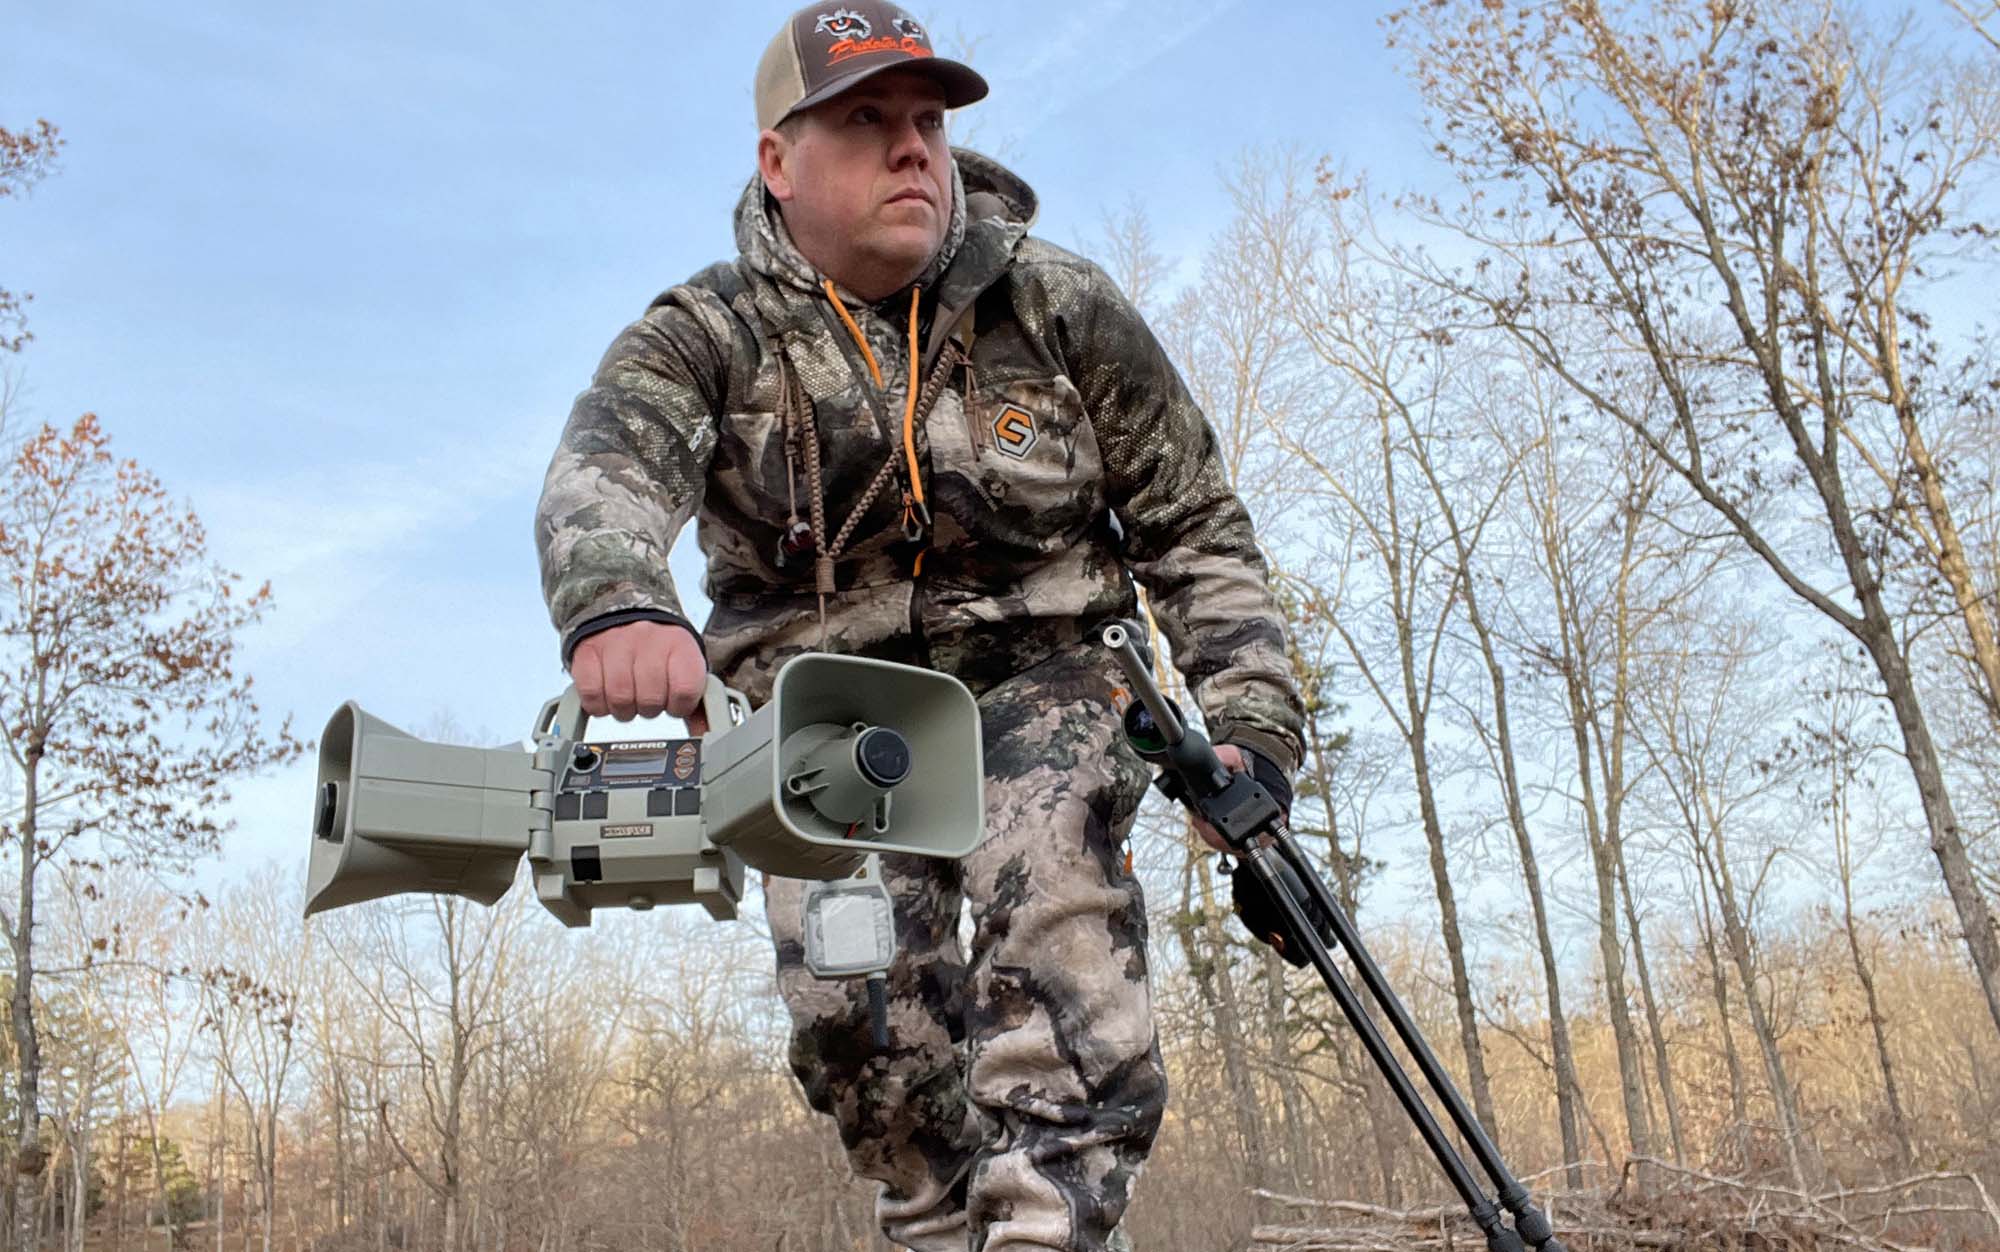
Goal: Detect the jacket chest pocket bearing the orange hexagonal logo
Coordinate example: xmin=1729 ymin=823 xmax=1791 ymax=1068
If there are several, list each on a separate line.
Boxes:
xmin=928 ymin=376 xmax=1104 ymax=552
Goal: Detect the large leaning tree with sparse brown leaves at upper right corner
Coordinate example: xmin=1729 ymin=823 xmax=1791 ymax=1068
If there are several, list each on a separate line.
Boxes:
xmin=1396 ymin=0 xmax=2000 ymax=1028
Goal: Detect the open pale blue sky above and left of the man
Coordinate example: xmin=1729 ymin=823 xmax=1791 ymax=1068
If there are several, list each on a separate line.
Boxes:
xmin=0 ymin=0 xmax=1424 ymax=866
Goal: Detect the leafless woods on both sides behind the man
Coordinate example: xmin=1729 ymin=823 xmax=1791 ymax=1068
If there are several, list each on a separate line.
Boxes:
xmin=11 ymin=0 xmax=2000 ymax=1252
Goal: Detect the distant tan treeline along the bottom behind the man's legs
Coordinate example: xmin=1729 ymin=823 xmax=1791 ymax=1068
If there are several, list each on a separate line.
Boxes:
xmin=0 ymin=852 xmax=2000 ymax=1250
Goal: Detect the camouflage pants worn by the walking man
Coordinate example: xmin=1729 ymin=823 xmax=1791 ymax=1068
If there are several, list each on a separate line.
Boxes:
xmin=766 ymin=648 xmax=1166 ymax=1252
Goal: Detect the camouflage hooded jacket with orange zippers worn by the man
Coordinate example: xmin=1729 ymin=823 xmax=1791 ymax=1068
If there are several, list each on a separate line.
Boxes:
xmin=536 ymin=150 xmax=1302 ymax=772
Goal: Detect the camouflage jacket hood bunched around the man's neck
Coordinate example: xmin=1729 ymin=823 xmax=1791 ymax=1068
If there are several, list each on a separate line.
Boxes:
xmin=736 ymin=148 xmax=1040 ymax=296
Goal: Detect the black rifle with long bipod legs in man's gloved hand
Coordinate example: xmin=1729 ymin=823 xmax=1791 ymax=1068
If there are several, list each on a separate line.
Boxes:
xmin=1102 ymin=622 xmax=1568 ymax=1252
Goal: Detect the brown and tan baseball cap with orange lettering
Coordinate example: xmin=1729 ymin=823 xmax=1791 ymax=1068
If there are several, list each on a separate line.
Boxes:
xmin=756 ymin=0 xmax=986 ymax=130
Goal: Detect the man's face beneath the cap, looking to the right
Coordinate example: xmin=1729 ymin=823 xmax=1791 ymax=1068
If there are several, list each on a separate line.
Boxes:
xmin=758 ymin=70 xmax=952 ymax=300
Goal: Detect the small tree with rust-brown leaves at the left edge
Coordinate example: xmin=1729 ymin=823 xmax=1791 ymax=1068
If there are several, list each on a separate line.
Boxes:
xmin=0 ymin=416 xmax=298 ymax=1252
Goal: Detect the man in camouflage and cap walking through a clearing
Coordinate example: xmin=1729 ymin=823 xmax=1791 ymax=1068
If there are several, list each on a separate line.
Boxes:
xmin=536 ymin=0 xmax=1302 ymax=1252
